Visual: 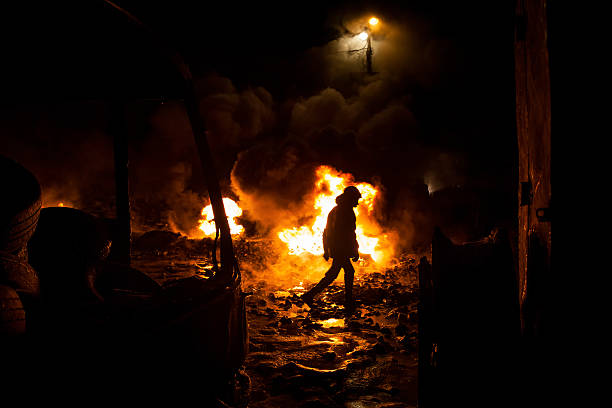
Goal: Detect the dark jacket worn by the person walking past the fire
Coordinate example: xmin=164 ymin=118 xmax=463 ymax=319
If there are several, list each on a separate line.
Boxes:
xmin=323 ymin=195 xmax=359 ymax=258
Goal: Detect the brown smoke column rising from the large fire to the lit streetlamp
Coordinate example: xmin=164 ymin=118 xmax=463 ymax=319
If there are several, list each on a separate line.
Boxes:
xmin=226 ymin=15 xmax=462 ymax=252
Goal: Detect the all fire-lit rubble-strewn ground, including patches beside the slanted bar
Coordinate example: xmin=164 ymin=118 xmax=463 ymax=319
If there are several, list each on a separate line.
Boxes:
xmin=132 ymin=231 xmax=418 ymax=408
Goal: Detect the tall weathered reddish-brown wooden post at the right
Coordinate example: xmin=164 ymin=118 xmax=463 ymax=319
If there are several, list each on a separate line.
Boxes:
xmin=514 ymin=0 xmax=551 ymax=336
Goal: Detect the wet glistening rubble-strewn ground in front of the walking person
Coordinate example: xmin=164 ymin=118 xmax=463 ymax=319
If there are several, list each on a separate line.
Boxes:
xmin=246 ymin=264 xmax=417 ymax=408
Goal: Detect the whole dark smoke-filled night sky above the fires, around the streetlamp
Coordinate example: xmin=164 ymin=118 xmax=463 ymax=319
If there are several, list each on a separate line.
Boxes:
xmin=0 ymin=1 xmax=516 ymax=245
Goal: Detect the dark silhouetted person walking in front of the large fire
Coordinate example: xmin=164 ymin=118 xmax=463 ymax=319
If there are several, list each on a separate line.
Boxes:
xmin=302 ymin=186 xmax=361 ymax=314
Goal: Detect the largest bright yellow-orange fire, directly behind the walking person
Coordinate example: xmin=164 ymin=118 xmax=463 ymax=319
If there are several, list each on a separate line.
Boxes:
xmin=278 ymin=166 xmax=388 ymax=262
